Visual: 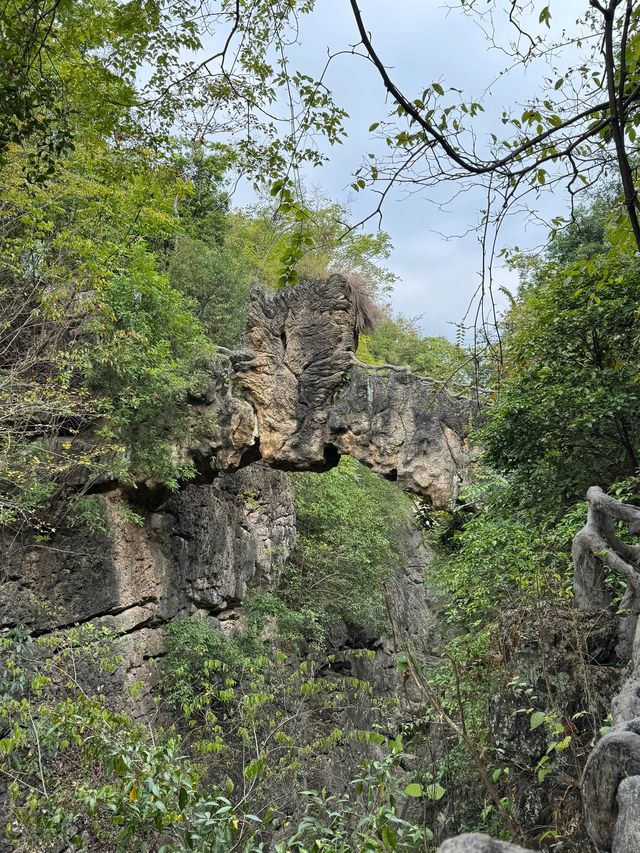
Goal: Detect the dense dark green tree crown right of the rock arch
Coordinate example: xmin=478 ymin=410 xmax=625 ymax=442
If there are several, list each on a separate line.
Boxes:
xmin=480 ymin=240 xmax=640 ymax=510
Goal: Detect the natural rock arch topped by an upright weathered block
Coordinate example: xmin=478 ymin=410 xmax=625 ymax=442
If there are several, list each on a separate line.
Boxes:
xmin=183 ymin=276 xmax=476 ymax=508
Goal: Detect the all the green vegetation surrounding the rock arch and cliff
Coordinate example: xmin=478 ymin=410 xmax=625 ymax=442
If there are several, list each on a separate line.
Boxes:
xmin=0 ymin=0 xmax=640 ymax=853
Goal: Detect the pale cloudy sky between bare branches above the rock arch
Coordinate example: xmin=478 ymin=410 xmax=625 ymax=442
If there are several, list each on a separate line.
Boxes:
xmin=228 ymin=0 xmax=587 ymax=337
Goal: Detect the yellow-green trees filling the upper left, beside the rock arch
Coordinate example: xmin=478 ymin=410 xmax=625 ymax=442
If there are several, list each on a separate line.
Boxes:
xmin=0 ymin=0 xmax=388 ymax=533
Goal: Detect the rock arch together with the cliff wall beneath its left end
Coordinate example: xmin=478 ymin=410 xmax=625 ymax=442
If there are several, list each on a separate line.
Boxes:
xmin=0 ymin=276 xmax=476 ymax=710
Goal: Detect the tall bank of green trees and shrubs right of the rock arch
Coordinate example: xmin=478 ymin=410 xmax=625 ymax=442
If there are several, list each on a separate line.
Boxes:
xmin=416 ymin=195 xmax=640 ymax=843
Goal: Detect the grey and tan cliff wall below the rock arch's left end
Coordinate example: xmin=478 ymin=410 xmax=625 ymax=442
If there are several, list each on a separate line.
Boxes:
xmin=0 ymin=463 xmax=295 ymax=713
